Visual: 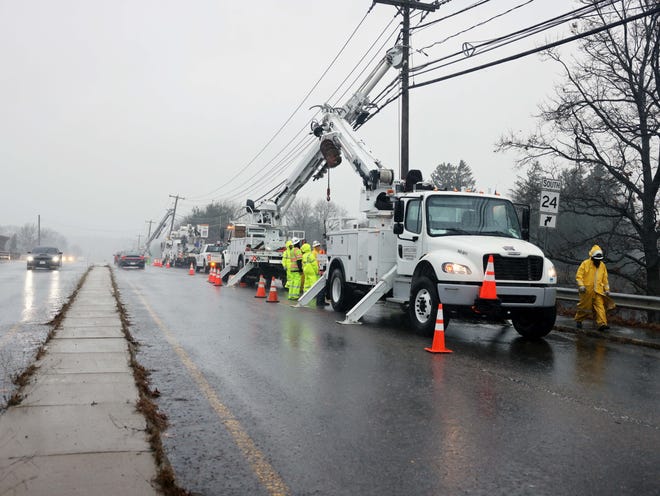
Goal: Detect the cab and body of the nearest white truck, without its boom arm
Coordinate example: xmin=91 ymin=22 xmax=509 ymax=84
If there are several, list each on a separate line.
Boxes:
xmin=328 ymin=189 xmax=556 ymax=337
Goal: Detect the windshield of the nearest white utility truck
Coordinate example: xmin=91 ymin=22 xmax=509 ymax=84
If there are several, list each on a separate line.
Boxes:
xmin=426 ymin=195 xmax=522 ymax=239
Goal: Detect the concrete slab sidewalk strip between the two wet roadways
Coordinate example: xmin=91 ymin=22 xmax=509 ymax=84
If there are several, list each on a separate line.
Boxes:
xmin=0 ymin=267 xmax=160 ymax=496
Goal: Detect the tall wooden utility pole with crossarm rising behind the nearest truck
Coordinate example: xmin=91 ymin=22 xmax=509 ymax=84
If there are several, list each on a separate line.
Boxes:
xmin=373 ymin=0 xmax=439 ymax=179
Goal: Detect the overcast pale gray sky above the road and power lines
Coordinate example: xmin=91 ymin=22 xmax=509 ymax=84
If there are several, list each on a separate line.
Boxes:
xmin=0 ymin=0 xmax=577 ymax=252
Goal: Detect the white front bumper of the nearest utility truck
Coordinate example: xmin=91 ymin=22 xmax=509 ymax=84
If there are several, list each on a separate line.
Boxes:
xmin=438 ymin=282 xmax=557 ymax=307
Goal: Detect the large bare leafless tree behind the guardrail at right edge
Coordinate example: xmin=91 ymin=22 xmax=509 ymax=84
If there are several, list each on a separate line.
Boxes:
xmin=499 ymin=0 xmax=660 ymax=295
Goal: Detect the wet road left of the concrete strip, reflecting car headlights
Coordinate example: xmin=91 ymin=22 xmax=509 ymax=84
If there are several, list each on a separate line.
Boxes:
xmin=0 ymin=260 xmax=87 ymax=408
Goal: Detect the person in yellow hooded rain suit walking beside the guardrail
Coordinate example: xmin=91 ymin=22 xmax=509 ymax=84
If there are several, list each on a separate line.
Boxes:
xmin=574 ymin=245 xmax=616 ymax=331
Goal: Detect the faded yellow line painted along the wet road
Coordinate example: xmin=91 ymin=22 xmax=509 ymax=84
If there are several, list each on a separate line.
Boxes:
xmin=138 ymin=294 xmax=290 ymax=496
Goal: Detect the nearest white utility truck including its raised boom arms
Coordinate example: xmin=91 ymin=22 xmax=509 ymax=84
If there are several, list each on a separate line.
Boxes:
xmin=240 ymin=46 xmax=557 ymax=338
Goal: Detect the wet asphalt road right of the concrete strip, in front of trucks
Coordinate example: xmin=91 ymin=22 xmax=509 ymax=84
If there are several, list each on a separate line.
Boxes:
xmin=115 ymin=267 xmax=660 ymax=495
